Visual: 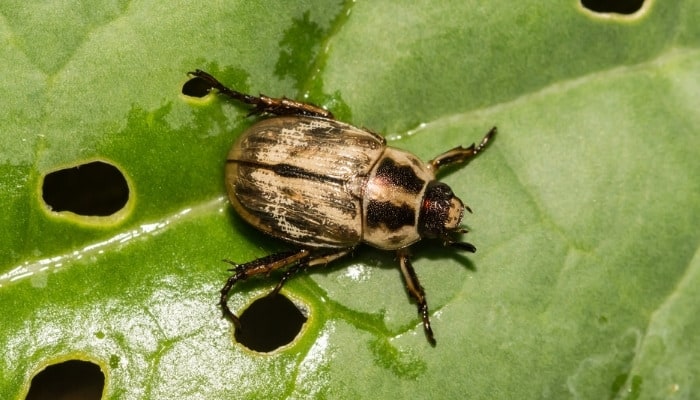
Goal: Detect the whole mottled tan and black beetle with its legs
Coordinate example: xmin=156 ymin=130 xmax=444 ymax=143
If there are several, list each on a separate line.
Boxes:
xmin=189 ymin=70 xmax=496 ymax=346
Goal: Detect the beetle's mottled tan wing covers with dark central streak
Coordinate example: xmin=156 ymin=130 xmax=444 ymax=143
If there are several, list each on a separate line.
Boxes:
xmin=226 ymin=117 xmax=385 ymax=247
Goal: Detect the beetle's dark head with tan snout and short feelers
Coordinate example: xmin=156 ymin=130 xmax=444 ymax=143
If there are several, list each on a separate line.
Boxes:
xmin=418 ymin=181 xmax=476 ymax=253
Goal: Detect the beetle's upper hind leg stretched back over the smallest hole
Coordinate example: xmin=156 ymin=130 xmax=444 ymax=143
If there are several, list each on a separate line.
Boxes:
xmin=188 ymin=69 xmax=333 ymax=119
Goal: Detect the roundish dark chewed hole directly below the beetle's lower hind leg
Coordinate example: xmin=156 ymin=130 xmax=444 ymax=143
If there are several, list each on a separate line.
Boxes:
xmin=234 ymin=293 xmax=307 ymax=353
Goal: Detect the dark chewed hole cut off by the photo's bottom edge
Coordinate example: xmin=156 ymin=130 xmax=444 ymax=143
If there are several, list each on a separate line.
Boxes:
xmin=26 ymin=360 xmax=105 ymax=400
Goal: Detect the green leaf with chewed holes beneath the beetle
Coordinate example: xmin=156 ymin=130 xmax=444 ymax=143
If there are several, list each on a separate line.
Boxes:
xmin=0 ymin=0 xmax=700 ymax=399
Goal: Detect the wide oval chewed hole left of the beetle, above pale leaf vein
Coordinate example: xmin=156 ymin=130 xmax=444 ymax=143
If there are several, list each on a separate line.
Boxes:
xmin=41 ymin=161 xmax=130 ymax=217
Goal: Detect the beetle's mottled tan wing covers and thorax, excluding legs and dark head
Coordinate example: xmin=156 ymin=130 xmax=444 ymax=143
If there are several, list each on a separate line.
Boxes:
xmin=226 ymin=116 xmax=454 ymax=250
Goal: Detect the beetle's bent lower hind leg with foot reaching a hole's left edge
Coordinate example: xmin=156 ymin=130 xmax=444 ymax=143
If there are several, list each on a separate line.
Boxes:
xmin=219 ymin=249 xmax=311 ymax=329
